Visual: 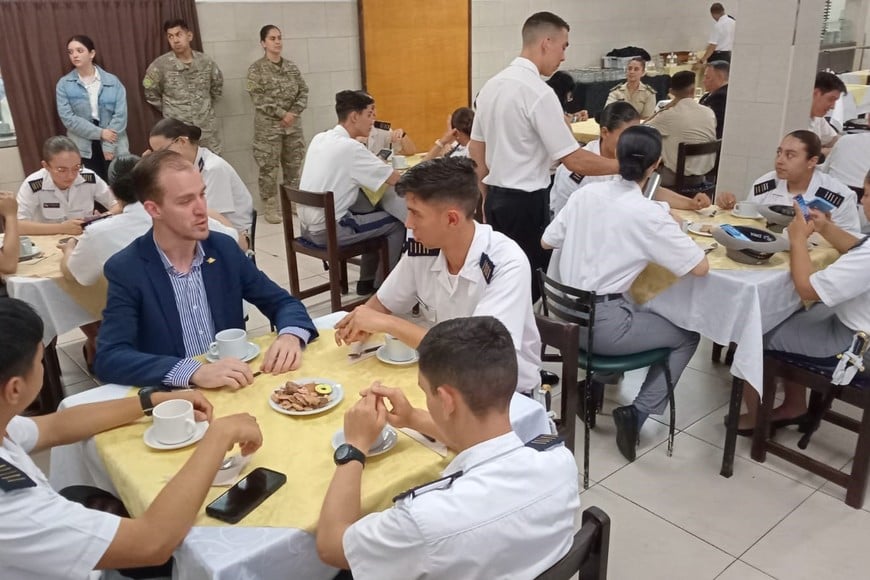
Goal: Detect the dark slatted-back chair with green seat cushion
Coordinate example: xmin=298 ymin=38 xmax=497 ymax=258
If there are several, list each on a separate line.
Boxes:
xmin=538 ymin=268 xmax=677 ymax=489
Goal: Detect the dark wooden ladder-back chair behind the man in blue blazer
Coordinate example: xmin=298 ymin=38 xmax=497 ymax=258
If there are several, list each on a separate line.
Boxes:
xmin=280 ymin=185 xmax=389 ymax=312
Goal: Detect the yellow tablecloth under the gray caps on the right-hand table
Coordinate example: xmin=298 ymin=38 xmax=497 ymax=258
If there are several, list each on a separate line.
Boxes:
xmin=630 ymin=210 xmax=840 ymax=304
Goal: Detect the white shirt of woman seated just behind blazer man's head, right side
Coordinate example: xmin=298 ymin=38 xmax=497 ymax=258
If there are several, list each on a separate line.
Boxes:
xmin=194 ymin=147 xmax=254 ymax=232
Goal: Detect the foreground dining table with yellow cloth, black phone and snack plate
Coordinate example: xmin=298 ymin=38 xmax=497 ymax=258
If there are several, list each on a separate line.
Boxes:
xmin=50 ymin=313 xmax=546 ymax=580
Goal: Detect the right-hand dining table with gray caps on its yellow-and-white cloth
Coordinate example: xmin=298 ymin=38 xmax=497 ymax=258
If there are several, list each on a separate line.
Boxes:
xmin=630 ymin=206 xmax=839 ymax=477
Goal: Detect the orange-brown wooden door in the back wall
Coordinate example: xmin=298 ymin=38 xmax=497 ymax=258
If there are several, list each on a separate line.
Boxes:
xmin=359 ymin=0 xmax=471 ymax=152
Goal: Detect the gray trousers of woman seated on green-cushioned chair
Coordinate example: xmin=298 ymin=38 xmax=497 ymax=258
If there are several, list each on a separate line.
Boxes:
xmin=580 ymin=298 xmax=701 ymax=415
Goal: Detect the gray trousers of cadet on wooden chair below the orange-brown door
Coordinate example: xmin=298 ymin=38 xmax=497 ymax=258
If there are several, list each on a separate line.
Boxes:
xmin=302 ymin=211 xmax=405 ymax=286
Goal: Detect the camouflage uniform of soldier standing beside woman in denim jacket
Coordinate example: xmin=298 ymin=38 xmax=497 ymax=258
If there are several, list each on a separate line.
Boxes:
xmin=142 ymin=50 xmax=224 ymax=155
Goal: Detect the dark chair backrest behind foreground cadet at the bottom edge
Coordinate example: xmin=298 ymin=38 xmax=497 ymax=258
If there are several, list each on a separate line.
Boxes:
xmin=535 ymin=506 xmax=610 ymax=580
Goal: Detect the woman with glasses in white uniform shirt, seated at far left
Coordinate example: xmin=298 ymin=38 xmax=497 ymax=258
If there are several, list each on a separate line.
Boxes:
xmin=18 ymin=136 xmax=120 ymax=236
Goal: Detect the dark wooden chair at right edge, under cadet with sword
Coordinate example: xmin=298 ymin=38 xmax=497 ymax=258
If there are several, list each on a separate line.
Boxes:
xmin=752 ymin=352 xmax=870 ymax=509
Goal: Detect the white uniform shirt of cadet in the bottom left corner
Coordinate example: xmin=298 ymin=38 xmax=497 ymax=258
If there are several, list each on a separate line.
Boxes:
xmin=0 ymin=417 xmax=121 ymax=580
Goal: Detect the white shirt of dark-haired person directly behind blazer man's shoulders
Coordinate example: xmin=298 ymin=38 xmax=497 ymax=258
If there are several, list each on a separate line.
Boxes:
xmin=67 ymin=202 xmax=239 ymax=286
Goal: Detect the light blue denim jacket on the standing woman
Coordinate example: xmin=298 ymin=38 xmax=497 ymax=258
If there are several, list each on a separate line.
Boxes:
xmin=56 ymin=65 xmax=130 ymax=159
